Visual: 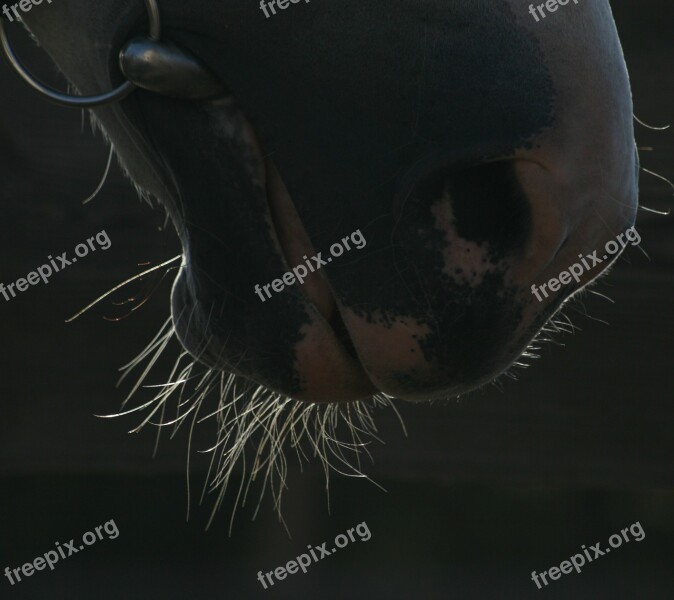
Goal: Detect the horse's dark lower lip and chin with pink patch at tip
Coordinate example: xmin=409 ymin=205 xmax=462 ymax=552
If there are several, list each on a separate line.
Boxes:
xmin=104 ymin=85 xmax=376 ymax=401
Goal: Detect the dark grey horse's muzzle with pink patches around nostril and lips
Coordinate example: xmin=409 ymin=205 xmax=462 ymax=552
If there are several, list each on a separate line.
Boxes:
xmin=19 ymin=0 xmax=636 ymax=401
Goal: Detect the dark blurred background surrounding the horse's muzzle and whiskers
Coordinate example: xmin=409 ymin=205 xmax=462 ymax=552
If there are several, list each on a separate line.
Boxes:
xmin=0 ymin=0 xmax=674 ymax=600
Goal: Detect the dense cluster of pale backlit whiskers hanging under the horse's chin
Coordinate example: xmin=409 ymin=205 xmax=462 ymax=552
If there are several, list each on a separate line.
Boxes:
xmin=102 ymin=319 xmax=404 ymax=531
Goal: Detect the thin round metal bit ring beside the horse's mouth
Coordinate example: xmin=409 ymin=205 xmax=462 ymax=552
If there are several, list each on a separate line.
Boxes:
xmin=0 ymin=0 xmax=161 ymax=108
